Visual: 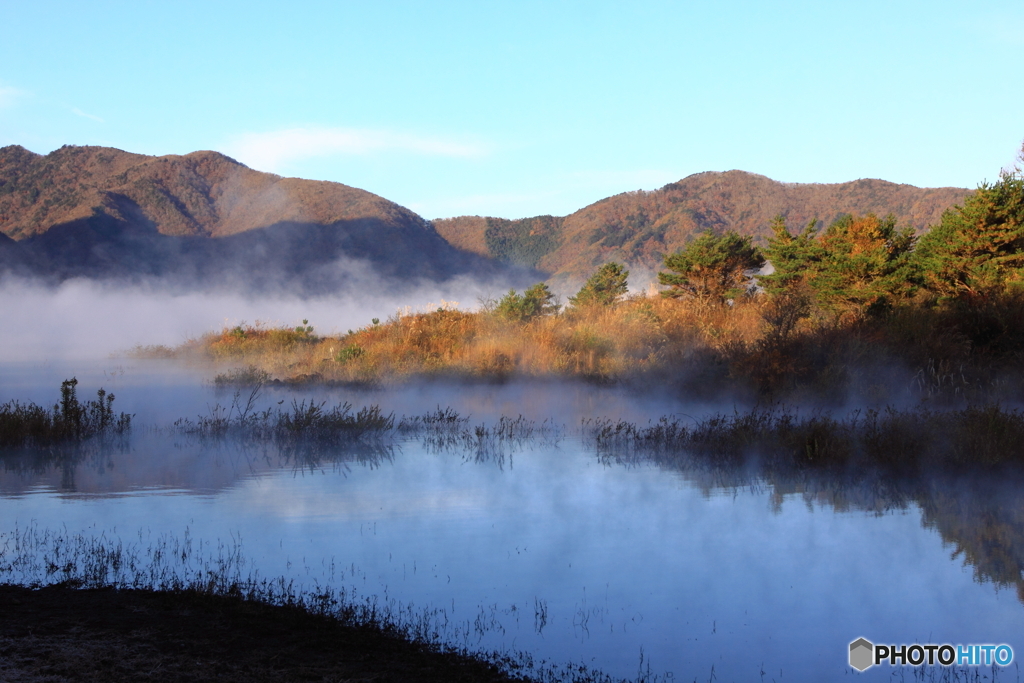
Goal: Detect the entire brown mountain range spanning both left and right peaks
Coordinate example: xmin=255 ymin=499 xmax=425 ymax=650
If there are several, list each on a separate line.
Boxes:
xmin=0 ymin=145 xmax=969 ymax=292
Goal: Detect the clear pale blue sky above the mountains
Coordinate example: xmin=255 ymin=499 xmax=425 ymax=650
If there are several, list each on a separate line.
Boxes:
xmin=0 ymin=0 xmax=1024 ymax=218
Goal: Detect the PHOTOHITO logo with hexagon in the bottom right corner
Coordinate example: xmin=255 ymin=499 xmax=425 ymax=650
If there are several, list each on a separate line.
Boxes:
xmin=850 ymin=638 xmax=1014 ymax=671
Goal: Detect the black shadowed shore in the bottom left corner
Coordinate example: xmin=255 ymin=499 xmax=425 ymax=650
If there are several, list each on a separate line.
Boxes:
xmin=0 ymin=586 xmax=521 ymax=683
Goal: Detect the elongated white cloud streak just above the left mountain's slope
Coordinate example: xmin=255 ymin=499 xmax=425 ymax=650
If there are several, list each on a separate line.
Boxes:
xmin=223 ymin=128 xmax=487 ymax=171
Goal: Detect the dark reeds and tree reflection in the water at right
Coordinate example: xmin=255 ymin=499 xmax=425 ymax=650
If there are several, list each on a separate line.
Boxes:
xmin=584 ymin=405 xmax=1024 ymax=602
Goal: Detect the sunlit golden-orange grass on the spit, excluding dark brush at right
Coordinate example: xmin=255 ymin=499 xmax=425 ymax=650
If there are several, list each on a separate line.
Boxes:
xmin=144 ymin=297 xmax=765 ymax=383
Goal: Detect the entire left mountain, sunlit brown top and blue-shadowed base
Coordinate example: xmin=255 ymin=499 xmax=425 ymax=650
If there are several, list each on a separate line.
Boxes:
xmin=0 ymin=145 xmax=537 ymax=293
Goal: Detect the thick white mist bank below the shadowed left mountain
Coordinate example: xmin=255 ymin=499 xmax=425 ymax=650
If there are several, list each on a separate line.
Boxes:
xmin=0 ymin=264 xmax=507 ymax=362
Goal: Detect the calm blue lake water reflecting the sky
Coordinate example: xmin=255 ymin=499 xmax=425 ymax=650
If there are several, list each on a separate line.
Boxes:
xmin=0 ymin=360 xmax=1024 ymax=681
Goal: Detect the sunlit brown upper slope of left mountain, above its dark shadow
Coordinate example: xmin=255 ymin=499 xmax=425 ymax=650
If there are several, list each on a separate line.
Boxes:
xmin=0 ymin=145 xmax=427 ymax=240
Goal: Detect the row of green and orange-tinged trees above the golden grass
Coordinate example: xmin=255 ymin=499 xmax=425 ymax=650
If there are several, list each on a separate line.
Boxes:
xmin=497 ymin=147 xmax=1024 ymax=321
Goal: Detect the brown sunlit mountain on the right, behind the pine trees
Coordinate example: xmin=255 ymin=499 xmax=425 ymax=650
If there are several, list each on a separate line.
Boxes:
xmin=433 ymin=171 xmax=969 ymax=282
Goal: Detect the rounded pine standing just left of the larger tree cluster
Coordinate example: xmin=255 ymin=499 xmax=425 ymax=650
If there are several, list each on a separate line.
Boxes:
xmin=657 ymin=230 xmax=765 ymax=305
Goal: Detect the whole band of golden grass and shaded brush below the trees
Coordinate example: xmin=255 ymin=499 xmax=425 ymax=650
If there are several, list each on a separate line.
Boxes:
xmin=137 ymin=296 xmax=1024 ymax=399
